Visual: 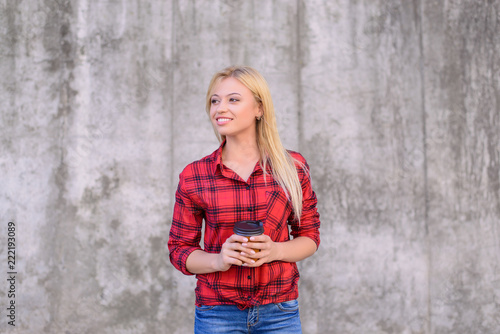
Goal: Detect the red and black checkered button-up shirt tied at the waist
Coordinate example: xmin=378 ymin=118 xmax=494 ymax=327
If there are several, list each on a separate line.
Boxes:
xmin=168 ymin=144 xmax=320 ymax=309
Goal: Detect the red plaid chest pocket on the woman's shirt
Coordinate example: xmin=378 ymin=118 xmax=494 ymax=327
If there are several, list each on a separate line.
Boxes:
xmin=264 ymin=189 xmax=292 ymax=241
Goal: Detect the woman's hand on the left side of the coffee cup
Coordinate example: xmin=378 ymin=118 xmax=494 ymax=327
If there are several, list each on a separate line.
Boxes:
xmin=216 ymin=234 xmax=257 ymax=271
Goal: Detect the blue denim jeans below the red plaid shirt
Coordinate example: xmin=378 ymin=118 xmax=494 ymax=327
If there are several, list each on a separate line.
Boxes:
xmin=194 ymin=300 xmax=302 ymax=334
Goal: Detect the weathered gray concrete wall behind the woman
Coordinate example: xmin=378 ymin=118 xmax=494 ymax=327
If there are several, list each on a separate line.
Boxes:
xmin=0 ymin=0 xmax=500 ymax=334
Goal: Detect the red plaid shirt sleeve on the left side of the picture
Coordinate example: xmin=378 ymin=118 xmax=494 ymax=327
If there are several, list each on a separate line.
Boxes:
xmin=168 ymin=170 xmax=204 ymax=275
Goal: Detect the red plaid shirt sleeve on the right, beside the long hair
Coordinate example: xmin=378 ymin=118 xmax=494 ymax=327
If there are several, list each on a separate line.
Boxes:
xmin=291 ymin=153 xmax=320 ymax=247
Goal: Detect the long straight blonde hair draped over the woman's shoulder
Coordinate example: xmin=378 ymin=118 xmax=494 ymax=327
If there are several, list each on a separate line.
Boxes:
xmin=206 ymin=66 xmax=304 ymax=222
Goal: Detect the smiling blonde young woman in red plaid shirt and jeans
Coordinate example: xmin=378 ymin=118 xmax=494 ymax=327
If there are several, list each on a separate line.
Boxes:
xmin=168 ymin=67 xmax=320 ymax=334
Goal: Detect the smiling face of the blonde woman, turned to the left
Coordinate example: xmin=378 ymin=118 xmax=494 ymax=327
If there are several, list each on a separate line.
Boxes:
xmin=210 ymin=77 xmax=262 ymax=139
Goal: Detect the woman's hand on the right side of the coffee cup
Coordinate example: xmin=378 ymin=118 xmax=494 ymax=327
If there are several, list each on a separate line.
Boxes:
xmin=241 ymin=234 xmax=281 ymax=267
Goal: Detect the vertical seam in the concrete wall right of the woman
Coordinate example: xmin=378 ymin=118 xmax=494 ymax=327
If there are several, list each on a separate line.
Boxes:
xmin=418 ymin=0 xmax=432 ymax=333
